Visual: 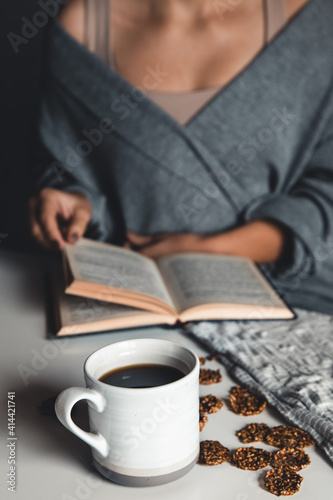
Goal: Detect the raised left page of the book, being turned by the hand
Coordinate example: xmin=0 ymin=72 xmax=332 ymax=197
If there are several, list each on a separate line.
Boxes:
xmin=65 ymin=238 xmax=174 ymax=307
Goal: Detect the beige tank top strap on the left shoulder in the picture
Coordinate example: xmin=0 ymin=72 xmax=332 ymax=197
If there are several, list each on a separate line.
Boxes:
xmin=84 ymin=0 xmax=112 ymax=64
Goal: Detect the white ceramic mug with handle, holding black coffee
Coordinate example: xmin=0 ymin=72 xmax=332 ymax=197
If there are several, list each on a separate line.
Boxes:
xmin=55 ymin=339 xmax=200 ymax=486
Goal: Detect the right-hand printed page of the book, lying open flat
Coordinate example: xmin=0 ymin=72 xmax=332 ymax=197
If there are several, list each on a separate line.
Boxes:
xmin=157 ymin=253 xmax=285 ymax=312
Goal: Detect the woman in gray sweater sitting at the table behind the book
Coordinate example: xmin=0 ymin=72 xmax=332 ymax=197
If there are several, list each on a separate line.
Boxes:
xmin=30 ymin=0 xmax=333 ymax=310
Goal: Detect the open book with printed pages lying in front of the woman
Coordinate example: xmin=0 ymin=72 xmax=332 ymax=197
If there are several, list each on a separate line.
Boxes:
xmin=50 ymin=238 xmax=294 ymax=335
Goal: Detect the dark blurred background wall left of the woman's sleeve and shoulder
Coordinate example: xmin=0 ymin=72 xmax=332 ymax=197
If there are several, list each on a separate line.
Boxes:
xmin=0 ymin=0 xmax=47 ymax=250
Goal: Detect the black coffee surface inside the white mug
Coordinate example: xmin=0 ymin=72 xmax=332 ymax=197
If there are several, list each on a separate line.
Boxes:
xmin=99 ymin=364 xmax=185 ymax=389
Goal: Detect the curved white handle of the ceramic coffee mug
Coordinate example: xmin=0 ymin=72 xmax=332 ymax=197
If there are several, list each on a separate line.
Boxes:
xmin=55 ymin=387 xmax=109 ymax=458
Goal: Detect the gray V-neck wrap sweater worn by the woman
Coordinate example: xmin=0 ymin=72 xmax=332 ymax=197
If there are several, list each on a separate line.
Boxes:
xmin=36 ymin=0 xmax=333 ymax=313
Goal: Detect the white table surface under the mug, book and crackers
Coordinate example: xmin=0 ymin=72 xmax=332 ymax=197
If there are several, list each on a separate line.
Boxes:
xmin=0 ymin=251 xmax=333 ymax=500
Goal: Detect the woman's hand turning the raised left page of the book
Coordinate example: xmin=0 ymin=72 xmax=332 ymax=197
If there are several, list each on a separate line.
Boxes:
xmin=29 ymin=188 xmax=92 ymax=250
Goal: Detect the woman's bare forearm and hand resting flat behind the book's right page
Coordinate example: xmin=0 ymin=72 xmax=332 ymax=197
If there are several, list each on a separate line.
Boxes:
xmin=125 ymin=220 xmax=287 ymax=264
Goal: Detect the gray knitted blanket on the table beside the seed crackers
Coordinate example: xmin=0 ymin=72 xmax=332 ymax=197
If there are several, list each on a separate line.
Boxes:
xmin=185 ymin=310 xmax=333 ymax=463
